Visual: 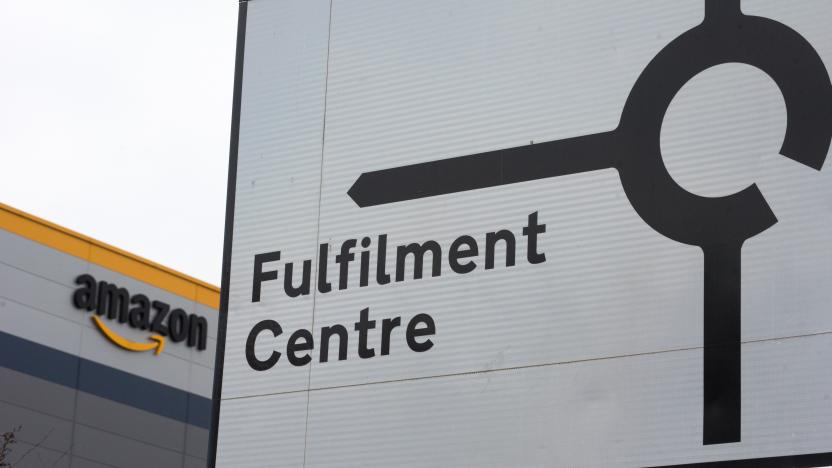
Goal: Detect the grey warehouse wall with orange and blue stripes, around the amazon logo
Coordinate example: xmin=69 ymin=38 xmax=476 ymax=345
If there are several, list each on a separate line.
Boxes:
xmin=0 ymin=204 xmax=218 ymax=468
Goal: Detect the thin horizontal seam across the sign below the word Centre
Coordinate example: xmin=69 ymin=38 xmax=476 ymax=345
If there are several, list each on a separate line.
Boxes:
xmin=223 ymin=330 xmax=832 ymax=401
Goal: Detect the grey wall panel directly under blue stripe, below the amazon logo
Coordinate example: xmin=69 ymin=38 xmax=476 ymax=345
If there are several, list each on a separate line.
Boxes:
xmin=75 ymin=392 xmax=185 ymax=451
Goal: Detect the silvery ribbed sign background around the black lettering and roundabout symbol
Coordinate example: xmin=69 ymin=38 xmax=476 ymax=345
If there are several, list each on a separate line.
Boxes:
xmin=217 ymin=0 xmax=832 ymax=467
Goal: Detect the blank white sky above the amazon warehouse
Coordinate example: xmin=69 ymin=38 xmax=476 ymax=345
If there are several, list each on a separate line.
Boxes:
xmin=0 ymin=0 xmax=237 ymax=284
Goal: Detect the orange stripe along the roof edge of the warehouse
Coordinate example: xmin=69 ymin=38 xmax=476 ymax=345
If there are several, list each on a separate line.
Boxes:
xmin=0 ymin=203 xmax=219 ymax=309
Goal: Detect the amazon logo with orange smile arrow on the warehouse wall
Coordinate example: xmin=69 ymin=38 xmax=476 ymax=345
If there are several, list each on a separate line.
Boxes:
xmin=72 ymin=274 xmax=208 ymax=355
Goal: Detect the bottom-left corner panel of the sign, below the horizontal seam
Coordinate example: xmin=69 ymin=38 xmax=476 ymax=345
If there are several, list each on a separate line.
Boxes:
xmin=217 ymin=392 xmax=307 ymax=468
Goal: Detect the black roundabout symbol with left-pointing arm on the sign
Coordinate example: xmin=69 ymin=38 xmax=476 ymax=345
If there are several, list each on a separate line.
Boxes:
xmin=348 ymin=0 xmax=832 ymax=444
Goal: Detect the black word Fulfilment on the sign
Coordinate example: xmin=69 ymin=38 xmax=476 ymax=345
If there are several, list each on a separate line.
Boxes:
xmin=251 ymin=212 xmax=546 ymax=302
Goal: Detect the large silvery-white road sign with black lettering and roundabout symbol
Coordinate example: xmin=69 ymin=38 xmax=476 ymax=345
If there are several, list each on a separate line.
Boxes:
xmin=214 ymin=0 xmax=832 ymax=467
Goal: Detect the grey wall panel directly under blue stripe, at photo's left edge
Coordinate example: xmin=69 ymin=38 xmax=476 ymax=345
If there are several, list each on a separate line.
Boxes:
xmin=0 ymin=366 xmax=76 ymax=420
